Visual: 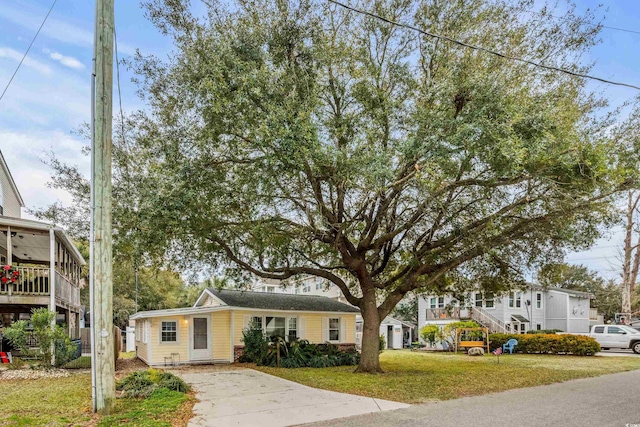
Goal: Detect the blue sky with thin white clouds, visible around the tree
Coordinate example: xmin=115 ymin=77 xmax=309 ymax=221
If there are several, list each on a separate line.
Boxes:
xmin=0 ymin=0 xmax=640 ymax=278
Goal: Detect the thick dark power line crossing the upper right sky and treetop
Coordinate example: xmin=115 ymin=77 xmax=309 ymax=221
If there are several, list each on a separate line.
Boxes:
xmin=328 ymin=0 xmax=640 ymax=90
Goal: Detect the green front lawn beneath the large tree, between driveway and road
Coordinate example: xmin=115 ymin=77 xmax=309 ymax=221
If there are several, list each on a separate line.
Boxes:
xmin=255 ymin=350 xmax=640 ymax=403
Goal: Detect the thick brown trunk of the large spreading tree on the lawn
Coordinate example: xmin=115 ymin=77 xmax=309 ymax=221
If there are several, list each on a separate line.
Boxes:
xmin=355 ymin=289 xmax=382 ymax=374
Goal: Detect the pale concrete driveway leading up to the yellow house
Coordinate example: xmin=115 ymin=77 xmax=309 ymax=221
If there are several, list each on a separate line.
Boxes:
xmin=174 ymin=369 xmax=409 ymax=427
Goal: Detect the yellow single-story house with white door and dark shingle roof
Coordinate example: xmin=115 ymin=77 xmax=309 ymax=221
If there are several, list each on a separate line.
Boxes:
xmin=131 ymin=288 xmax=360 ymax=366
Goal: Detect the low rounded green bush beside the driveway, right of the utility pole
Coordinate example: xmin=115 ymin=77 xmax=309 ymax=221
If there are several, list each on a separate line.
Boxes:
xmin=116 ymin=368 xmax=190 ymax=398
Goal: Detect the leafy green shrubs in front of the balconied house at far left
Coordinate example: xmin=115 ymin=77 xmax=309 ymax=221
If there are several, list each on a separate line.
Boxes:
xmin=5 ymin=307 xmax=77 ymax=366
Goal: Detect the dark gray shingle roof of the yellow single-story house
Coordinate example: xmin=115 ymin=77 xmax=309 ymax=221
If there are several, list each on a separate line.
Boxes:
xmin=207 ymin=288 xmax=360 ymax=313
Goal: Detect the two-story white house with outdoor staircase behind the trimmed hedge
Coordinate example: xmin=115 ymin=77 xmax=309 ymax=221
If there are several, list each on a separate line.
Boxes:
xmin=418 ymin=285 xmax=597 ymax=342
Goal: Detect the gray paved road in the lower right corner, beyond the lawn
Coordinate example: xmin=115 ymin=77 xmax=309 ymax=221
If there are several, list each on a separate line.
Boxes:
xmin=302 ymin=370 xmax=640 ymax=427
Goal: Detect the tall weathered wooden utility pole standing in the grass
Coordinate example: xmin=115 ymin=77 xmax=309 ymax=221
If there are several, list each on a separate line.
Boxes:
xmin=91 ymin=0 xmax=116 ymax=414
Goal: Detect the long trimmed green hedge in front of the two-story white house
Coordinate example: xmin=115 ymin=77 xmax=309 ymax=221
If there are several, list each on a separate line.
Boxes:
xmin=489 ymin=334 xmax=600 ymax=356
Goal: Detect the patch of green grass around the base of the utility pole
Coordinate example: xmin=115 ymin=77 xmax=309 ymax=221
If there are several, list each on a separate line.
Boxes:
xmin=0 ymin=373 xmax=190 ymax=427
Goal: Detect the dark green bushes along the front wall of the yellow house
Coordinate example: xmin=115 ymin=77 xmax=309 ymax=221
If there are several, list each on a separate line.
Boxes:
xmin=238 ymin=324 xmax=360 ymax=368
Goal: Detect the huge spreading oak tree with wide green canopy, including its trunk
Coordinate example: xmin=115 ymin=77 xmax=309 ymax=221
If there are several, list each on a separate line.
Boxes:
xmin=109 ymin=0 xmax=637 ymax=372
